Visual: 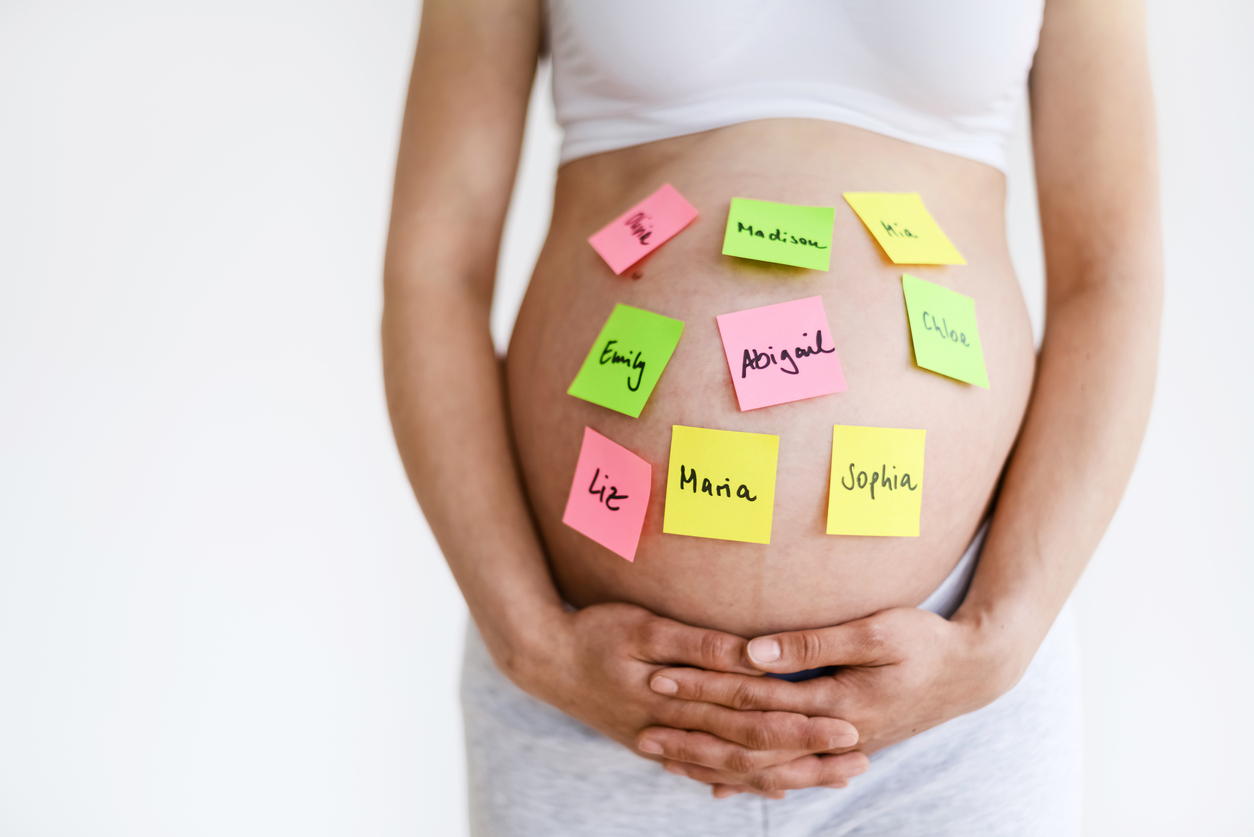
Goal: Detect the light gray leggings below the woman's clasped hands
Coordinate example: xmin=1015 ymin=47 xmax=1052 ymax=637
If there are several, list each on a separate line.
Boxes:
xmin=461 ymin=534 xmax=1081 ymax=837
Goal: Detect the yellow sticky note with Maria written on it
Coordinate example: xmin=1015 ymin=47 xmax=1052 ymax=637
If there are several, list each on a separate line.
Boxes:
xmin=662 ymin=424 xmax=780 ymax=543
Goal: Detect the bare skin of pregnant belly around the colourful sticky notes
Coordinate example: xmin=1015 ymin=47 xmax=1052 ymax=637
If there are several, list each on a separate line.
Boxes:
xmin=507 ymin=120 xmax=1033 ymax=635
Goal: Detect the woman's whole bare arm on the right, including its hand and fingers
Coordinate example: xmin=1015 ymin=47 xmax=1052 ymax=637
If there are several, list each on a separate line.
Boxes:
xmin=641 ymin=0 xmax=1162 ymax=789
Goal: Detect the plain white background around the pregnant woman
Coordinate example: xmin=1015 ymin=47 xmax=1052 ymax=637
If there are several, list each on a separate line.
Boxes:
xmin=0 ymin=0 xmax=1254 ymax=837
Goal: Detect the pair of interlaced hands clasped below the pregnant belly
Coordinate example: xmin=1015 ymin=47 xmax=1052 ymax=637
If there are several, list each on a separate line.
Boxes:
xmin=515 ymin=604 xmax=1017 ymax=798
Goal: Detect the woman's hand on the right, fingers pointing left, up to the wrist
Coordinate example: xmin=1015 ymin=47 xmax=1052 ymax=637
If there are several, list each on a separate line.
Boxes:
xmin=637 ymin=607 xmax=1026 ymax=797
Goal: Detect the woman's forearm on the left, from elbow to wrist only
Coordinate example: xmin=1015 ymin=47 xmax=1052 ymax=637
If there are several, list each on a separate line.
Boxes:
xmin=382 ymin=286 xmax=561 ymax=671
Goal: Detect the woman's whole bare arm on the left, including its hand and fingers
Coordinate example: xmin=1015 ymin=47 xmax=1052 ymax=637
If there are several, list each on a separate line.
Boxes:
xmin=382 ymin=0 xmax=865 ymax=788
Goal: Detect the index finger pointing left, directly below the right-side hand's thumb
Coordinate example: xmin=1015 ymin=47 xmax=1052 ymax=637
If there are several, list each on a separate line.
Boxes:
xmin=648 ymin=669 xmax=853 ymax=732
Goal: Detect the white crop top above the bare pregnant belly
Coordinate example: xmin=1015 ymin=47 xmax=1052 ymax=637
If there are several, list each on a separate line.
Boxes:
xmin=547 ymin=0 xmax=1045 ymax=171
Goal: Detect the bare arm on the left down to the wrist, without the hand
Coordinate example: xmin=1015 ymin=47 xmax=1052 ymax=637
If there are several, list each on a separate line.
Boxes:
xmin=382 ymin=0 xmax=562 ymax=674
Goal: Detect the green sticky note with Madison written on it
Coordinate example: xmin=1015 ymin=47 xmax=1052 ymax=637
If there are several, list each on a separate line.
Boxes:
xmin=722 ymin=197 xmax=836 ymax=270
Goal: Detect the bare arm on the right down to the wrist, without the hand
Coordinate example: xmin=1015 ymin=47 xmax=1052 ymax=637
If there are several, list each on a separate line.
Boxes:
xmin=954 ymin=0 xmax=1162 ymax=683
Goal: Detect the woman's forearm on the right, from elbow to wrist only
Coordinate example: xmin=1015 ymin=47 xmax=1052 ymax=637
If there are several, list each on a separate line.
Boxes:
xmin=954 ymin=274 xmax=1161 ymax=680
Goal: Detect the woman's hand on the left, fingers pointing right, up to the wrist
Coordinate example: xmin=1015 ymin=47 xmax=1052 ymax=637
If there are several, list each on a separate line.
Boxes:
xmin=510 ymin=604 xmax=867 ymax=798
